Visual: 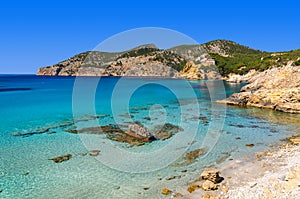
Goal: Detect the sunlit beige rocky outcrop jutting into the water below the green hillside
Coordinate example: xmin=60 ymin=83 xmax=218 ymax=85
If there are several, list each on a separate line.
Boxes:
xmin=219 ymin=63 xmax=300 ymax=113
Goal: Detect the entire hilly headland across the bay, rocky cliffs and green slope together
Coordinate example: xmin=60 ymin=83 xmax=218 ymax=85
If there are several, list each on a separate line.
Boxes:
xmin=37 ymin=40 xmax=300 ymax=79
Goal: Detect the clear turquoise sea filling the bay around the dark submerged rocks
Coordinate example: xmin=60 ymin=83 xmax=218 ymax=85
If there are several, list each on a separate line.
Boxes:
xmin=0 ymin=75 xmax=300 ymax=199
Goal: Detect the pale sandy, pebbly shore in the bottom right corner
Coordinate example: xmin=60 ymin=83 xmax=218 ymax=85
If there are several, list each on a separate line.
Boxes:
xmin=173 ymin=134 xmax=300 ymax=199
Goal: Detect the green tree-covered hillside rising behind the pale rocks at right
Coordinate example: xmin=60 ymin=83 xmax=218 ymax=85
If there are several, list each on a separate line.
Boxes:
xmin=205 ymin=40 xmax=300 ymax=76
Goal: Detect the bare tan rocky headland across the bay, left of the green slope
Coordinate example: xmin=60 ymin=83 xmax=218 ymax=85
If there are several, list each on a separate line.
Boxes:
xmin=37 ymin=40 xmax=250 ymax=79
